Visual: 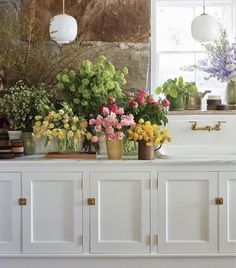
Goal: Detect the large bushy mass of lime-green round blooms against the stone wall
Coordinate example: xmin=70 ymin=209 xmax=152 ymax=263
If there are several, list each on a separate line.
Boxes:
xmin=56 ymin=56 xmax=128 ymax=118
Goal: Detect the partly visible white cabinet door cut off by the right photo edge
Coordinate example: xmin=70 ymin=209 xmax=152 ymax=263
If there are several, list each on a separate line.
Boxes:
xmin=219 ymin=172 xmax=236 ymax=252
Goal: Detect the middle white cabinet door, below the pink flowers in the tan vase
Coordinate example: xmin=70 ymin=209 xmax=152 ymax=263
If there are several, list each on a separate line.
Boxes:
xmin=90 ymin=171 xmax=150 ymax=254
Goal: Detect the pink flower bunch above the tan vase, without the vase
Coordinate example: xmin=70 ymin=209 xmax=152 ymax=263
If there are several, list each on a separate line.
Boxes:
xmin=89 ymin=98 xmax=135 ymax=142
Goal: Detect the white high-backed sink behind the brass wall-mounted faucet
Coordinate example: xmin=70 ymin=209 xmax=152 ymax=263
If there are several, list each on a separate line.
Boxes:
xmin=161 ymin=113 xmax=236 ymax=158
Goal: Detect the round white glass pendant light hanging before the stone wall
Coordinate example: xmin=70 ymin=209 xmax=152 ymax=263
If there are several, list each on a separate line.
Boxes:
xmin=49 ymin=0 xmax=77 ymax=44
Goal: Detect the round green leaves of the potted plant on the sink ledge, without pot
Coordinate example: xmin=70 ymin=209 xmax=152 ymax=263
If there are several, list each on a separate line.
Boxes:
xmin=156 ymin=76 xmax=198 ymax=99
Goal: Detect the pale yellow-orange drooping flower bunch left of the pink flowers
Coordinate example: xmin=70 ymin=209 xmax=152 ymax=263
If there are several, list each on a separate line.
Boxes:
xmin=33 ymin=102 xmax=87 ymax=151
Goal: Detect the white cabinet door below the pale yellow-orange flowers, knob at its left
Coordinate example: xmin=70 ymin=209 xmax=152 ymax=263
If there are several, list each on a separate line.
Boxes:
xmin=22 ymin=172 xmax=82 ymax=253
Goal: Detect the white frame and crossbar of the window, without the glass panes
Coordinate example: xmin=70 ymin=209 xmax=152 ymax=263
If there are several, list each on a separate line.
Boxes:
xmin=150 ymin=0 xmax=236 ymax=91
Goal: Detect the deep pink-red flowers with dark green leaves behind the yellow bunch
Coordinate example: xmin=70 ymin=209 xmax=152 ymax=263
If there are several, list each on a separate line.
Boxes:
xmin=119 ymin=89 xmax=170 ymax=125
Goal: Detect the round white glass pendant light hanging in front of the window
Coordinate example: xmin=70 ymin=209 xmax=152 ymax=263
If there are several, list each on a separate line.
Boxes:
xmin=191 ymin=0 xmax=218 ymax=42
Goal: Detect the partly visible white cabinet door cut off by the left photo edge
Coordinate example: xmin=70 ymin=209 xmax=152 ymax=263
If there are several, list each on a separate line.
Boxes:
xmin=0 ymin=173 xmax=21 ymax=253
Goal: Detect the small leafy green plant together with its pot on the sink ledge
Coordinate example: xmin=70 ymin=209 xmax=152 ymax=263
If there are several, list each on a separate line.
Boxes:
xmin=156 ymin=76 xmax=197 ymax=111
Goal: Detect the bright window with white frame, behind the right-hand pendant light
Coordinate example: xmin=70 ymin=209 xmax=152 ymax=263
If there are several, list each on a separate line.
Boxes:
xmin=151 ymin=0 xmax=236 ymax=103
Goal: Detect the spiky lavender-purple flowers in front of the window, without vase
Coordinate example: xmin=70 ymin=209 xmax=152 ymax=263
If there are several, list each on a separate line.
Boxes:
xmin=196 ymin=29 xmax=236 ymax=82
